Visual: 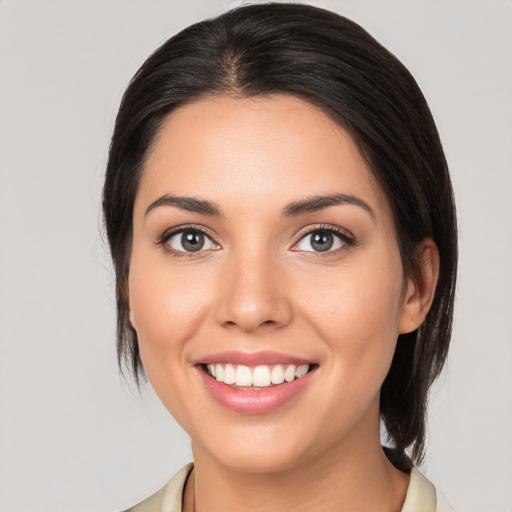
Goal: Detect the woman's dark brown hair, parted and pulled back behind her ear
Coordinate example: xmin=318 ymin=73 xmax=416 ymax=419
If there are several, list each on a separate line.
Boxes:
xmin=103 ymin=3 xmax=457 ymax=461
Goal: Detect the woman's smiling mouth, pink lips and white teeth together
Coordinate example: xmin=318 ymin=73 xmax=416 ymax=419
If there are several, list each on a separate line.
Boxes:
xmin=195 ymin=353 xmax=319 ymax=415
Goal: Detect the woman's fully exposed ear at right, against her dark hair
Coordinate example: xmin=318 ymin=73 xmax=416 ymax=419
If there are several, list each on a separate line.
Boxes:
xmin=398 ymin=238 xmax=439 ymax=334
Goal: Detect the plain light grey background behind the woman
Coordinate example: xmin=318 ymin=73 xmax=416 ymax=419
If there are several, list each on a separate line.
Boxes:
xmin=0 ymin=0 xmax=512 ymax=512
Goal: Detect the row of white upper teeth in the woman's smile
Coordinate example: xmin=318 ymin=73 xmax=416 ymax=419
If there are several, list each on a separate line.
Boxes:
xmin=207 ymin=363 xmax=309 ymax=388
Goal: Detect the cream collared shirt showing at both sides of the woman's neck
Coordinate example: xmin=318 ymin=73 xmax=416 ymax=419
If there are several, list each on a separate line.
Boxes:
xmin=126 ymin=463 xmax=453 ymax=512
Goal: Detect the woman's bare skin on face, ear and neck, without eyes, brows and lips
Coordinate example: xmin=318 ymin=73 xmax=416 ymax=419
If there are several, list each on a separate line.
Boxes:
xmin=129 ymin=95 xmax=438 ymax=512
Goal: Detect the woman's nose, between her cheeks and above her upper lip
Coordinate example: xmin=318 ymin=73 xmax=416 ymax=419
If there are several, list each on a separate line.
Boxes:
xmin=212 ymin=248 xmax=292 ymax=332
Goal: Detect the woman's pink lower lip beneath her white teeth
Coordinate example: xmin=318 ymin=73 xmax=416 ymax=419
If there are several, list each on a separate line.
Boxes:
xmin=198 ymin=367 xmax=315 ymax=414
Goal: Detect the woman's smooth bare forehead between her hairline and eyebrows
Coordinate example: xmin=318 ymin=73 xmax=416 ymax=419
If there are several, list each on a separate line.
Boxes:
xmin=136 ymin=95 xmax=387 ymax=220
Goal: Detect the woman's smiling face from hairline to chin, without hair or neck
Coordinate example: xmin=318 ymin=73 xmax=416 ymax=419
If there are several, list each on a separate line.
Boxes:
xmin=129 ymin=95 xmax=413 ymax=471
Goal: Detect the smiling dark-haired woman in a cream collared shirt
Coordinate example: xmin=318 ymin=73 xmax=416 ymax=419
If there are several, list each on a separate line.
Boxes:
xmin=103 ymin=4 xmax=457 ymax=512
